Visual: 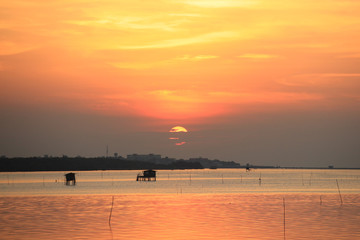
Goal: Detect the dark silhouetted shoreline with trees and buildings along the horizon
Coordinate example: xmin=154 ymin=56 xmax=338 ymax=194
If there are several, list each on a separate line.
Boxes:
xmin=0 ymin=157 xmax=360 ymax=172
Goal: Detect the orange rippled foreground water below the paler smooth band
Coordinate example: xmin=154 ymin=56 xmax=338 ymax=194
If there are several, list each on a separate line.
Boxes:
xmin=0 ymin=194 xmax=360 ymax=240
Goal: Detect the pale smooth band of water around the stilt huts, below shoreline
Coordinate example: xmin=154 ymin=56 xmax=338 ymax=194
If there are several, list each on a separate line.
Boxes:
xmin=0 ymin=169 xmax=360 ymax=196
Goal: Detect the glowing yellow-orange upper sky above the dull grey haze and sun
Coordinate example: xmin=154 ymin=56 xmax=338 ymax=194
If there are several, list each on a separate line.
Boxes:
xmin=0 ymin=0 xmax=360 ymax=126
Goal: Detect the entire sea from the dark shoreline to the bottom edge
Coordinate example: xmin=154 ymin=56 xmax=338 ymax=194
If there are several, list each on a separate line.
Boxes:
xmin=0 ymin=169 xmax=360 ymax=240
